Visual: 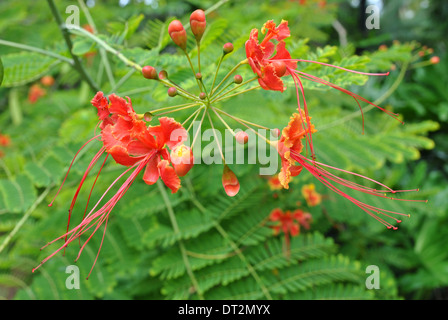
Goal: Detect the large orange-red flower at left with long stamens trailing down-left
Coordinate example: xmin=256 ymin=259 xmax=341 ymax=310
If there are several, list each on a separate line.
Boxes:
xmin=33 ymin=92 xmax=193 ymax=275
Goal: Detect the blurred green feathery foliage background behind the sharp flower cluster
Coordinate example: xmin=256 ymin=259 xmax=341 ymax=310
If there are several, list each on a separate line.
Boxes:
xmin=0 ymin=0 xmax=448 ymax=300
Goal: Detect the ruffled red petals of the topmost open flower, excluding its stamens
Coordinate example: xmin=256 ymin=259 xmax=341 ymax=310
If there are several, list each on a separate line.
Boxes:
xmin=246 ymin=20 xmax=297 ymax=92
